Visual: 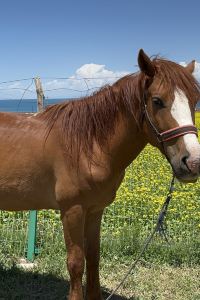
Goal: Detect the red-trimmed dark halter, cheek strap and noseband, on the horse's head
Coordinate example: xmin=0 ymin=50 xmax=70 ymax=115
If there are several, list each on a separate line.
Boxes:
xmin=142 ymin=92 xmax=198 ymax=147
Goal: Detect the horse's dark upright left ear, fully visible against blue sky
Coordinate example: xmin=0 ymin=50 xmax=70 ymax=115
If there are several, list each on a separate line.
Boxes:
xmin=138 ymin=49 xmax=155 ymax=77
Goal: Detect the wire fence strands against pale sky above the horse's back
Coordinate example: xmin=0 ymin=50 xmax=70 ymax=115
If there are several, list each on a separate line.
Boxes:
xmin=0 ymin=76 xmax=120 ymax=103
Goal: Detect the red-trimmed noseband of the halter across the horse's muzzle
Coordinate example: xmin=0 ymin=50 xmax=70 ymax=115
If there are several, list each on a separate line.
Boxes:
xmin=157 ymin=125 xmax=198 ymax=143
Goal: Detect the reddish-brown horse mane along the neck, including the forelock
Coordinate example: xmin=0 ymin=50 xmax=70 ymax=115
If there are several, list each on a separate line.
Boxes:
xmin=37 ymin=57 xmax=200 ymax=160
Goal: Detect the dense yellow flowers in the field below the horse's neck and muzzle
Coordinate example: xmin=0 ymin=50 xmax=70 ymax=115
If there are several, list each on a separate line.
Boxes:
xmin=104 ymin=139 xmax=200 ymax=240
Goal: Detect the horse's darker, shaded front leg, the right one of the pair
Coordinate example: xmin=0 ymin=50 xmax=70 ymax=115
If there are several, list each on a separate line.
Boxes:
xmin=85 ymin=210 xmax=103 ymax=300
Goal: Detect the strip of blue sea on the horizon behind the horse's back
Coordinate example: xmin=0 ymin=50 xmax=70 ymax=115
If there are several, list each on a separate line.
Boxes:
xmin=0 ymin=98 xmax=67 ymax=113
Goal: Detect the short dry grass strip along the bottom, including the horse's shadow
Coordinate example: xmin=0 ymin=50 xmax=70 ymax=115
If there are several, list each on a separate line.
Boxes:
xmin=0 ymin=254 xmax=200 ymax=300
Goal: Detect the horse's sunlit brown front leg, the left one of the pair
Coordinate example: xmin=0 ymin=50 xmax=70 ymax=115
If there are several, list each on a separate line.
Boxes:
xmin=61 ymin=205 xmax=85 ymax=300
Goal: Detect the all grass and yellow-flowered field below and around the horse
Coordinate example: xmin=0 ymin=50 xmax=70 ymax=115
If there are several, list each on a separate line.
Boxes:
xmin=0 ymin=113 xmax=200 ymax=300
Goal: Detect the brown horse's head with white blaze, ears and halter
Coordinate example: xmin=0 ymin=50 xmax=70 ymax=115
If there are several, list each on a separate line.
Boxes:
xmin=138 ymin=50 xmax=200 ymax=182
